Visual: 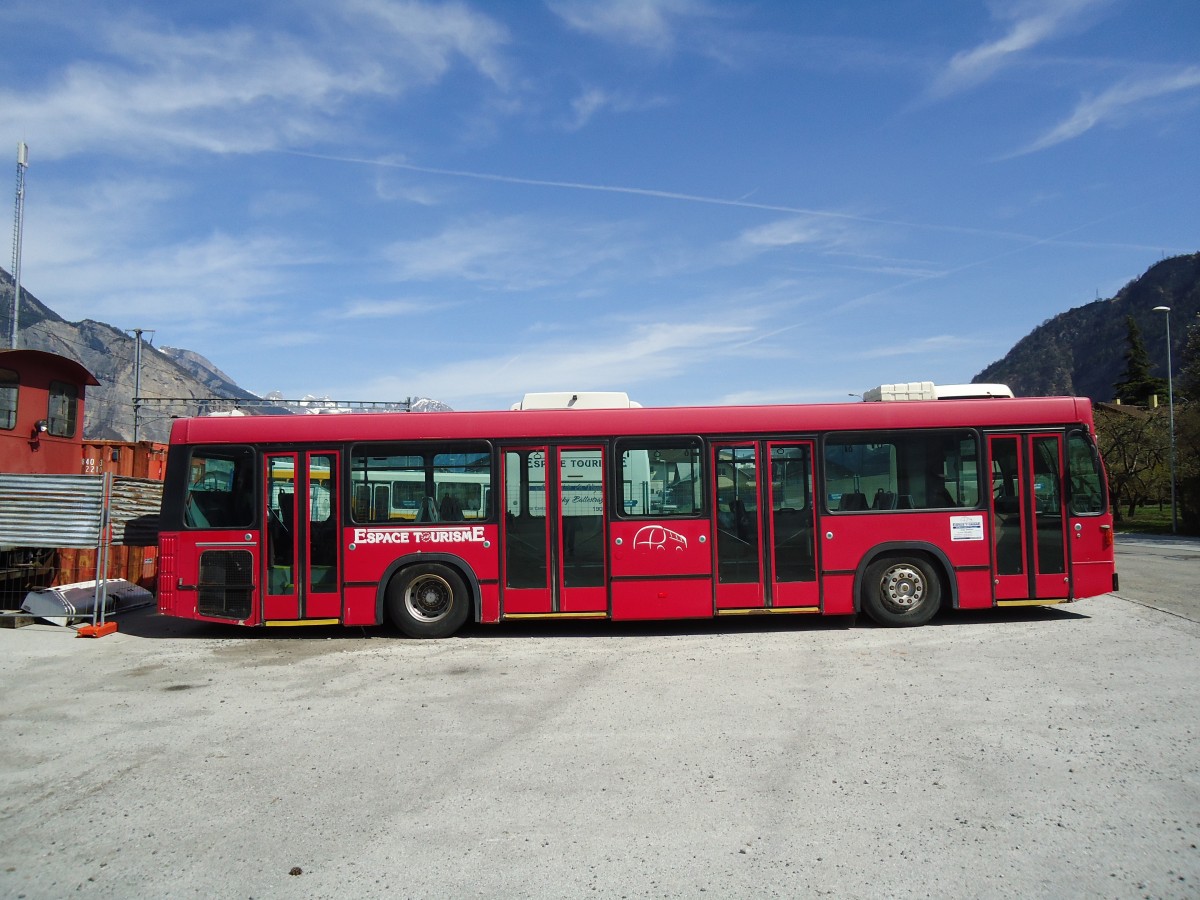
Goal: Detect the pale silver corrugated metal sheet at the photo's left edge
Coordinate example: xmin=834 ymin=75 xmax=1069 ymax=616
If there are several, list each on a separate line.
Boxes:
xmin=0 ymin=475 xmax=104 ymax=547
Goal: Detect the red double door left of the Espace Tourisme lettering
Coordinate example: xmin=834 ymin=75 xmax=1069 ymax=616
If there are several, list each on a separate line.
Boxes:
xmin=262 ymin=450 xmax=342 ymax=624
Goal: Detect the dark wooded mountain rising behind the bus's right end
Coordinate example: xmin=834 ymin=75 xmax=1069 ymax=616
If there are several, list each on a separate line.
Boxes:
xmin=973 ymin=253 xmax=1200 ymax=402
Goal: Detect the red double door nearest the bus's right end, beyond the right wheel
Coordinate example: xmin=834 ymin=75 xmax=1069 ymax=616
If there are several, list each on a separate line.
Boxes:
xmin=988 ymin=434 xmax=1070 ymax=601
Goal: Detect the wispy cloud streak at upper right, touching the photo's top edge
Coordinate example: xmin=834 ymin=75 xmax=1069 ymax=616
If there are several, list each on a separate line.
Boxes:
xmin=929 ymin=0 xmax=1110 ymax=98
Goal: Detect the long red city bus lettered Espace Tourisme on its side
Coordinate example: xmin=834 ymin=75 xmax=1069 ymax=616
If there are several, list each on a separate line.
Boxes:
xmin=158 ymin=397 xmax=1116 ymax=637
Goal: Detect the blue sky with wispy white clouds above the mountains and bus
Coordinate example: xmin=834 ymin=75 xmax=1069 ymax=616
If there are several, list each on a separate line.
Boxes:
xmin=0 ymin=0 xmax=1200 ymax=409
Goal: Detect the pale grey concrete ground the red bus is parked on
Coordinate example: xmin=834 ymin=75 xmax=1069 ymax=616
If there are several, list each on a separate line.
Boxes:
xmin=0 ymin=538 xmax=1200 ymax=898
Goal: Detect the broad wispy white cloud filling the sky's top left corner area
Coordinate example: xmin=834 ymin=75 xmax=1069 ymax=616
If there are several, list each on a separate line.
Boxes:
xmin=0 ymin=0 xmax=508 ymax=158
